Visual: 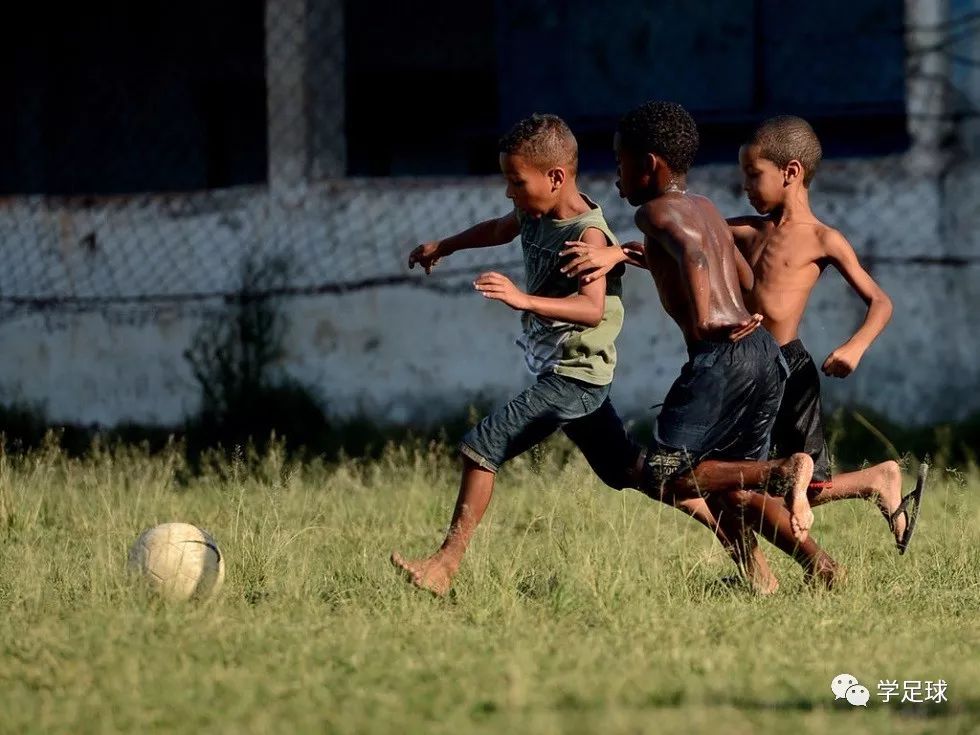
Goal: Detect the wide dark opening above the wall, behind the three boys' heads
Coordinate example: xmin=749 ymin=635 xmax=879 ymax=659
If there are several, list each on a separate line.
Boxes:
xmin=345 ymin=0 xmax=908 ymax=176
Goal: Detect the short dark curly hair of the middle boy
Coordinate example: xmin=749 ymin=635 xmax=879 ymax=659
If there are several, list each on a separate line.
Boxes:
xmin=616 ymin=101 xmax=699 ymax=174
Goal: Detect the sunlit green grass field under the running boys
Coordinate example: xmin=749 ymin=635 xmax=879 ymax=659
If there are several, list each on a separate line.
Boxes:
xmin=0 ymin=443 xmax=980 ymax=735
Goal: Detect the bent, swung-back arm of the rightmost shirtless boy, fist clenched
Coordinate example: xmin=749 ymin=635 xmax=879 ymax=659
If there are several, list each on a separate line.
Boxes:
xmin=822 ymin=230 xmax=892 ymax=378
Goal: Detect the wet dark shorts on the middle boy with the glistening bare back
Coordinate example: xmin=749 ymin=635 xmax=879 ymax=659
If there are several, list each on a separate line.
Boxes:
xmin=643 ymin=328 xmax=788 ymax=491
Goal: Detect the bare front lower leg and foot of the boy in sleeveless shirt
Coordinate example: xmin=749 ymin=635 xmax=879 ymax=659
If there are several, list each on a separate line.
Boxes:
xmin=391 ymin=456 xmax=496 ymax=595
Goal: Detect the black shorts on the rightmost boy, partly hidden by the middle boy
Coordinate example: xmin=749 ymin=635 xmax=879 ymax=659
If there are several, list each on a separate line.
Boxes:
xmin=772 ymin=339 xmax=831 ymax=488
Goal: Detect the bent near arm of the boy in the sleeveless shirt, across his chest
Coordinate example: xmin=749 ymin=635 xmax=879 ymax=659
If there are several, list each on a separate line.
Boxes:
xmin=473 ymin=229 xmax=606 ymax=327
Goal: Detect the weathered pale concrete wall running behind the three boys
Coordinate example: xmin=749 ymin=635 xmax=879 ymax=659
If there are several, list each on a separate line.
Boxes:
xmin=0 ymin=157 xmax=980 ymax=432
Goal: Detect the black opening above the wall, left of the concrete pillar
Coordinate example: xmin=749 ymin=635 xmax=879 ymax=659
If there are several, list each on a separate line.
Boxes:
xmin=0 ymin=0 xmax=266 ymax=195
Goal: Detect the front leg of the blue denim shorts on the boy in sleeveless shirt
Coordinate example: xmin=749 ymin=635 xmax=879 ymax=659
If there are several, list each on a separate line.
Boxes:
xmin=459 ymin=373 xmax=609 ymax=472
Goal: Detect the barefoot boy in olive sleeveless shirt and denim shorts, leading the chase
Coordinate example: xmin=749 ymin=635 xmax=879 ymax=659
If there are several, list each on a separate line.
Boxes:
xmin=391 ymin=115 xmax=636 ymax=594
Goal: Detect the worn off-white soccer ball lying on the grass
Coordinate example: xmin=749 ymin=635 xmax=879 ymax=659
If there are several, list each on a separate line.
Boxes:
xmin=129 ymin=523 xmax=225 ymax=600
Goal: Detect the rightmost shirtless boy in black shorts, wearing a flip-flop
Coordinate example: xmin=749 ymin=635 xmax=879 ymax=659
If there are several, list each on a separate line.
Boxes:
xmin=728 ymin=115 xmax=927 ymax=554
